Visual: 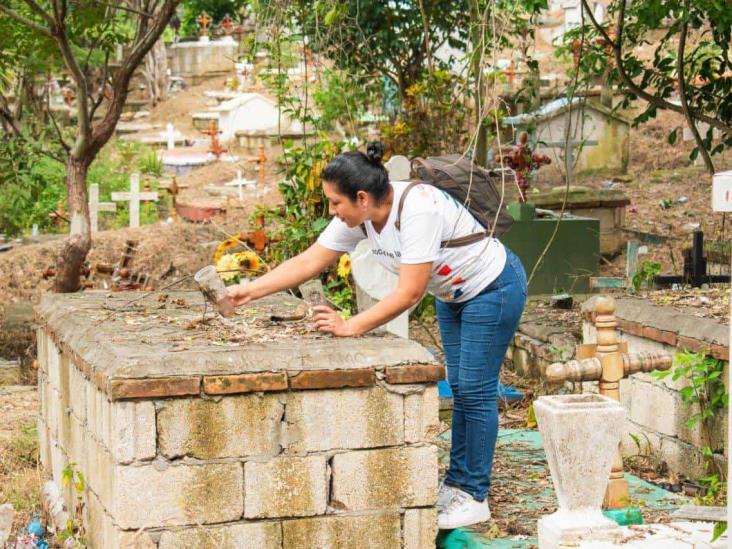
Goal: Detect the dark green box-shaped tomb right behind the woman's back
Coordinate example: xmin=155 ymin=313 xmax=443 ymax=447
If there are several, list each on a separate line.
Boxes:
xmin=499 ymin=204 xmax=600 ymax=295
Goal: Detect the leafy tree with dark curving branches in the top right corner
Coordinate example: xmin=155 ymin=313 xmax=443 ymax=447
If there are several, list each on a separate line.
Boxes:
xmin=566 ymin=0 xmax=732 ymax=173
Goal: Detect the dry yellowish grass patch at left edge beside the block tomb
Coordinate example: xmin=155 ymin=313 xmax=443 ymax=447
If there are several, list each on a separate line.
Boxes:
xmin=0 ymin=421 xmax=41 ymax=532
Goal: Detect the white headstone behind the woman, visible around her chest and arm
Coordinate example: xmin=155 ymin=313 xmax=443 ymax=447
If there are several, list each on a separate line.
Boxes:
xmin=351 ymin=155 xmax=410 ymax=338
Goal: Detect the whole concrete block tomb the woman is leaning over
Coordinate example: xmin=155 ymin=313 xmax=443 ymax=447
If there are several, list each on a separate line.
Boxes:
xmin=36 ymin=292 xmax=444 ymax=549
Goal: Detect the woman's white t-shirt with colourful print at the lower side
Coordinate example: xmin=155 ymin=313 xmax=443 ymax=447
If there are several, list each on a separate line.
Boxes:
xmin=318 ymin=181 xmax=506 ymax=303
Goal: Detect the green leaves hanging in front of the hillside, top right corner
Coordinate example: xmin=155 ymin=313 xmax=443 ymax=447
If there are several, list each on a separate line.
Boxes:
xmin=559 ymin=0 xmax=732 ymax=160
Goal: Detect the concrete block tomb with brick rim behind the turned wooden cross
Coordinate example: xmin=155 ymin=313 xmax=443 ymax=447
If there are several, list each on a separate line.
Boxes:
xmin=582 ymin=299 xmax=729 ymax=478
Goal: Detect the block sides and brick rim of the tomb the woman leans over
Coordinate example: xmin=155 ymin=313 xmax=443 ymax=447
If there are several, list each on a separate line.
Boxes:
xmin=37 ymin=292 xmax=444 ymax=549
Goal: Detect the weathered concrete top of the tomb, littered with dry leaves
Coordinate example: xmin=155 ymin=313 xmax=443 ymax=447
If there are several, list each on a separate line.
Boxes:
xmin=36 ymin=291 xmax=434 ymax=400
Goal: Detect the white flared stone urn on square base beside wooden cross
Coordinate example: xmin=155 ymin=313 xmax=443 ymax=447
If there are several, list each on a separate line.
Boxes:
xmin=534 ymin=395 xmax=625 ymax=549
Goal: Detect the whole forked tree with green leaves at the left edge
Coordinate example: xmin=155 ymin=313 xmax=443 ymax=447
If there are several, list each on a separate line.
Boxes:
xmin=0 ymin=0 xmax=181 ymax=292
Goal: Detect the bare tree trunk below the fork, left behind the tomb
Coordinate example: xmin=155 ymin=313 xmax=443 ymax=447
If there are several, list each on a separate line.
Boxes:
xmin=54 ymin=155 xmax=91 ymax=293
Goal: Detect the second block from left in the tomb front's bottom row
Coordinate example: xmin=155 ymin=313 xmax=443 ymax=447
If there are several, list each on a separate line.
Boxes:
xmin=158 ymin=522 xmax=282 ymax=549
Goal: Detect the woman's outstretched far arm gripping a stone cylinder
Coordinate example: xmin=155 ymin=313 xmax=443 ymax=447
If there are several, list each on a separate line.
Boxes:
xmin=227 ymin=242 xmax=343 ymax=306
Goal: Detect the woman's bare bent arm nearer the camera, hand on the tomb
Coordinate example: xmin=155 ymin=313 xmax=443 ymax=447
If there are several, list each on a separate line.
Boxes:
xmin=315 ymin=263 xmax=432 ymax=336
